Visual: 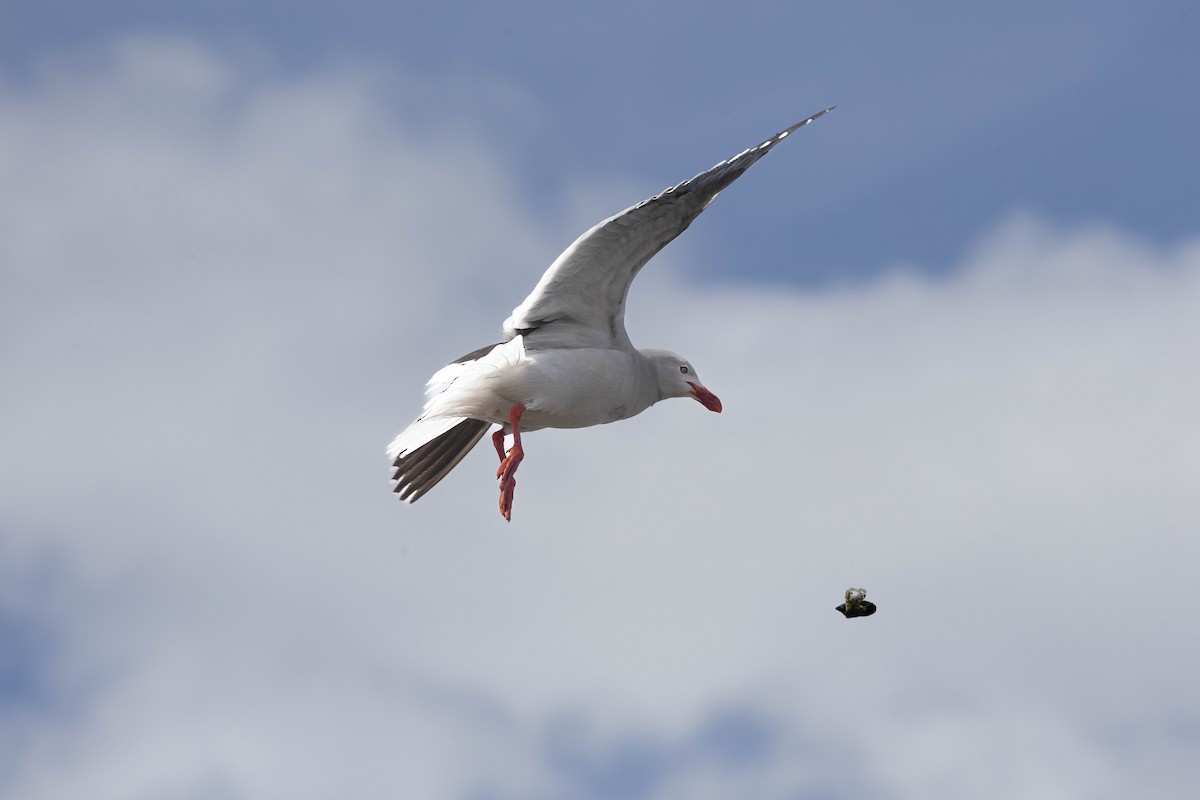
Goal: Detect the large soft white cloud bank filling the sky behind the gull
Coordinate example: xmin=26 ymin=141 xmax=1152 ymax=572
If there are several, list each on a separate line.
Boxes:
xmin=0 ymin=35 xmax=1200 ymax=800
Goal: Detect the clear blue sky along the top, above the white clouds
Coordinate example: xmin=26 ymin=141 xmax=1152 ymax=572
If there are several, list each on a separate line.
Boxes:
xmin=0 ymin=2 xmax=1200 ymax=284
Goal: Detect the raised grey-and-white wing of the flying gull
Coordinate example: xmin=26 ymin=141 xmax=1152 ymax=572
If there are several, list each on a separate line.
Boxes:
xmin=504 ymin=108 xmax=833 ymax=350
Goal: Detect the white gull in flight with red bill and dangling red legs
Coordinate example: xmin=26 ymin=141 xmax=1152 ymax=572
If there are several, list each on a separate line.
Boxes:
xmin=388 ymin=108 xmax=833 ymax=521
